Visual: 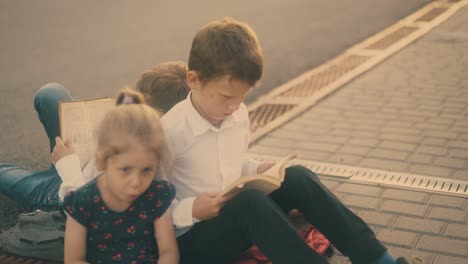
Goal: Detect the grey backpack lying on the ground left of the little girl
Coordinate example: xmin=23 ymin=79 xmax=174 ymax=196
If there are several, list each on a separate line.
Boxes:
xmin=0 ymin=210 xmax=66 ymax=261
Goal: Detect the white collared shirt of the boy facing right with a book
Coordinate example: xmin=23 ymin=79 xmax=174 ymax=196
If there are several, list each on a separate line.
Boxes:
xmin=161 ymin=94 xmax=259 ymax=235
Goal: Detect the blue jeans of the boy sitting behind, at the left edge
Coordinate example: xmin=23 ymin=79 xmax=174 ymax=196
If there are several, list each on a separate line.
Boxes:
xmin=0 ymin=83 xmax=72 ymax=210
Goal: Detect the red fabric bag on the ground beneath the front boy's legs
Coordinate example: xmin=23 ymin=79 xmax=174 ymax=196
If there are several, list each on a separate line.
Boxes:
xmin=231 ymin=225 xmax=331 ymax=264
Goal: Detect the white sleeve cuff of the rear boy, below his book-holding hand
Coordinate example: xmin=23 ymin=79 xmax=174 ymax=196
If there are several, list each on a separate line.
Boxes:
xmin=55 ymin=154 xmax=85 ymax=201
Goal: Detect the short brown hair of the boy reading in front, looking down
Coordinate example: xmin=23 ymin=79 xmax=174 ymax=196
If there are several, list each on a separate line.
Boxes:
xmin=188 ymin=17 xmax=263 ymax=86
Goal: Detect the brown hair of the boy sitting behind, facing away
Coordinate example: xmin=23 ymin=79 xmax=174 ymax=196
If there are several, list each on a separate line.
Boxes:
xmin=135 ymin=61 xmax=189 ymax=113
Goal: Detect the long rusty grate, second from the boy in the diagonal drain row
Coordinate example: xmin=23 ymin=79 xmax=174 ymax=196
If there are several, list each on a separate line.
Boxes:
xmin=277 ymin=55 xmax=370 ymax=97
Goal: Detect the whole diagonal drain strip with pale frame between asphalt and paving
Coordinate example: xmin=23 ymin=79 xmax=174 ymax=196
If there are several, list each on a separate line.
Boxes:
xmin=249 ymin=0 xmax=462 ymax=145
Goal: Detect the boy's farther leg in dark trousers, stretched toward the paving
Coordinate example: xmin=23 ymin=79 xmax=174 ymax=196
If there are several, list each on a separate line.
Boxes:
xmin=270 ymin=166 xmax=386 ymax=263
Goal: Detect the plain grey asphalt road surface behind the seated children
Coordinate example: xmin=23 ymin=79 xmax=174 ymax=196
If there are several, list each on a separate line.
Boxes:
xmin=0 ymin=0 xmax=430 ymax=172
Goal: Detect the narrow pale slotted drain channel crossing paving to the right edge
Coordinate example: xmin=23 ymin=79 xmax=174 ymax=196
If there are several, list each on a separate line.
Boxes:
xmin=251 ymin=154 xmax=468 ymax=197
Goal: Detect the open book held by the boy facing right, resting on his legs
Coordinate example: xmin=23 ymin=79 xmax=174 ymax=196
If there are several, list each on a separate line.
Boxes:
xmin=220 ymin=153 xmax=297 ymax=196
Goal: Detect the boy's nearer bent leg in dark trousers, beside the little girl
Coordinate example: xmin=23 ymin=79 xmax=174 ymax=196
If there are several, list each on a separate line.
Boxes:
xmin=177 ymin=190 xmax=327 ymax=264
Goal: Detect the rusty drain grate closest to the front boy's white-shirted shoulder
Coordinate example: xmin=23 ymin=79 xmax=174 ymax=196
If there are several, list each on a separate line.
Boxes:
xmin=249 ymin=104 xmax=295 ymax=132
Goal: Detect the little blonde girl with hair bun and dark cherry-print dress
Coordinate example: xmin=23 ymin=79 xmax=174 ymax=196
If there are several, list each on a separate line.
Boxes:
xmin=61 ymin=89 xmax=179 ymax=264
